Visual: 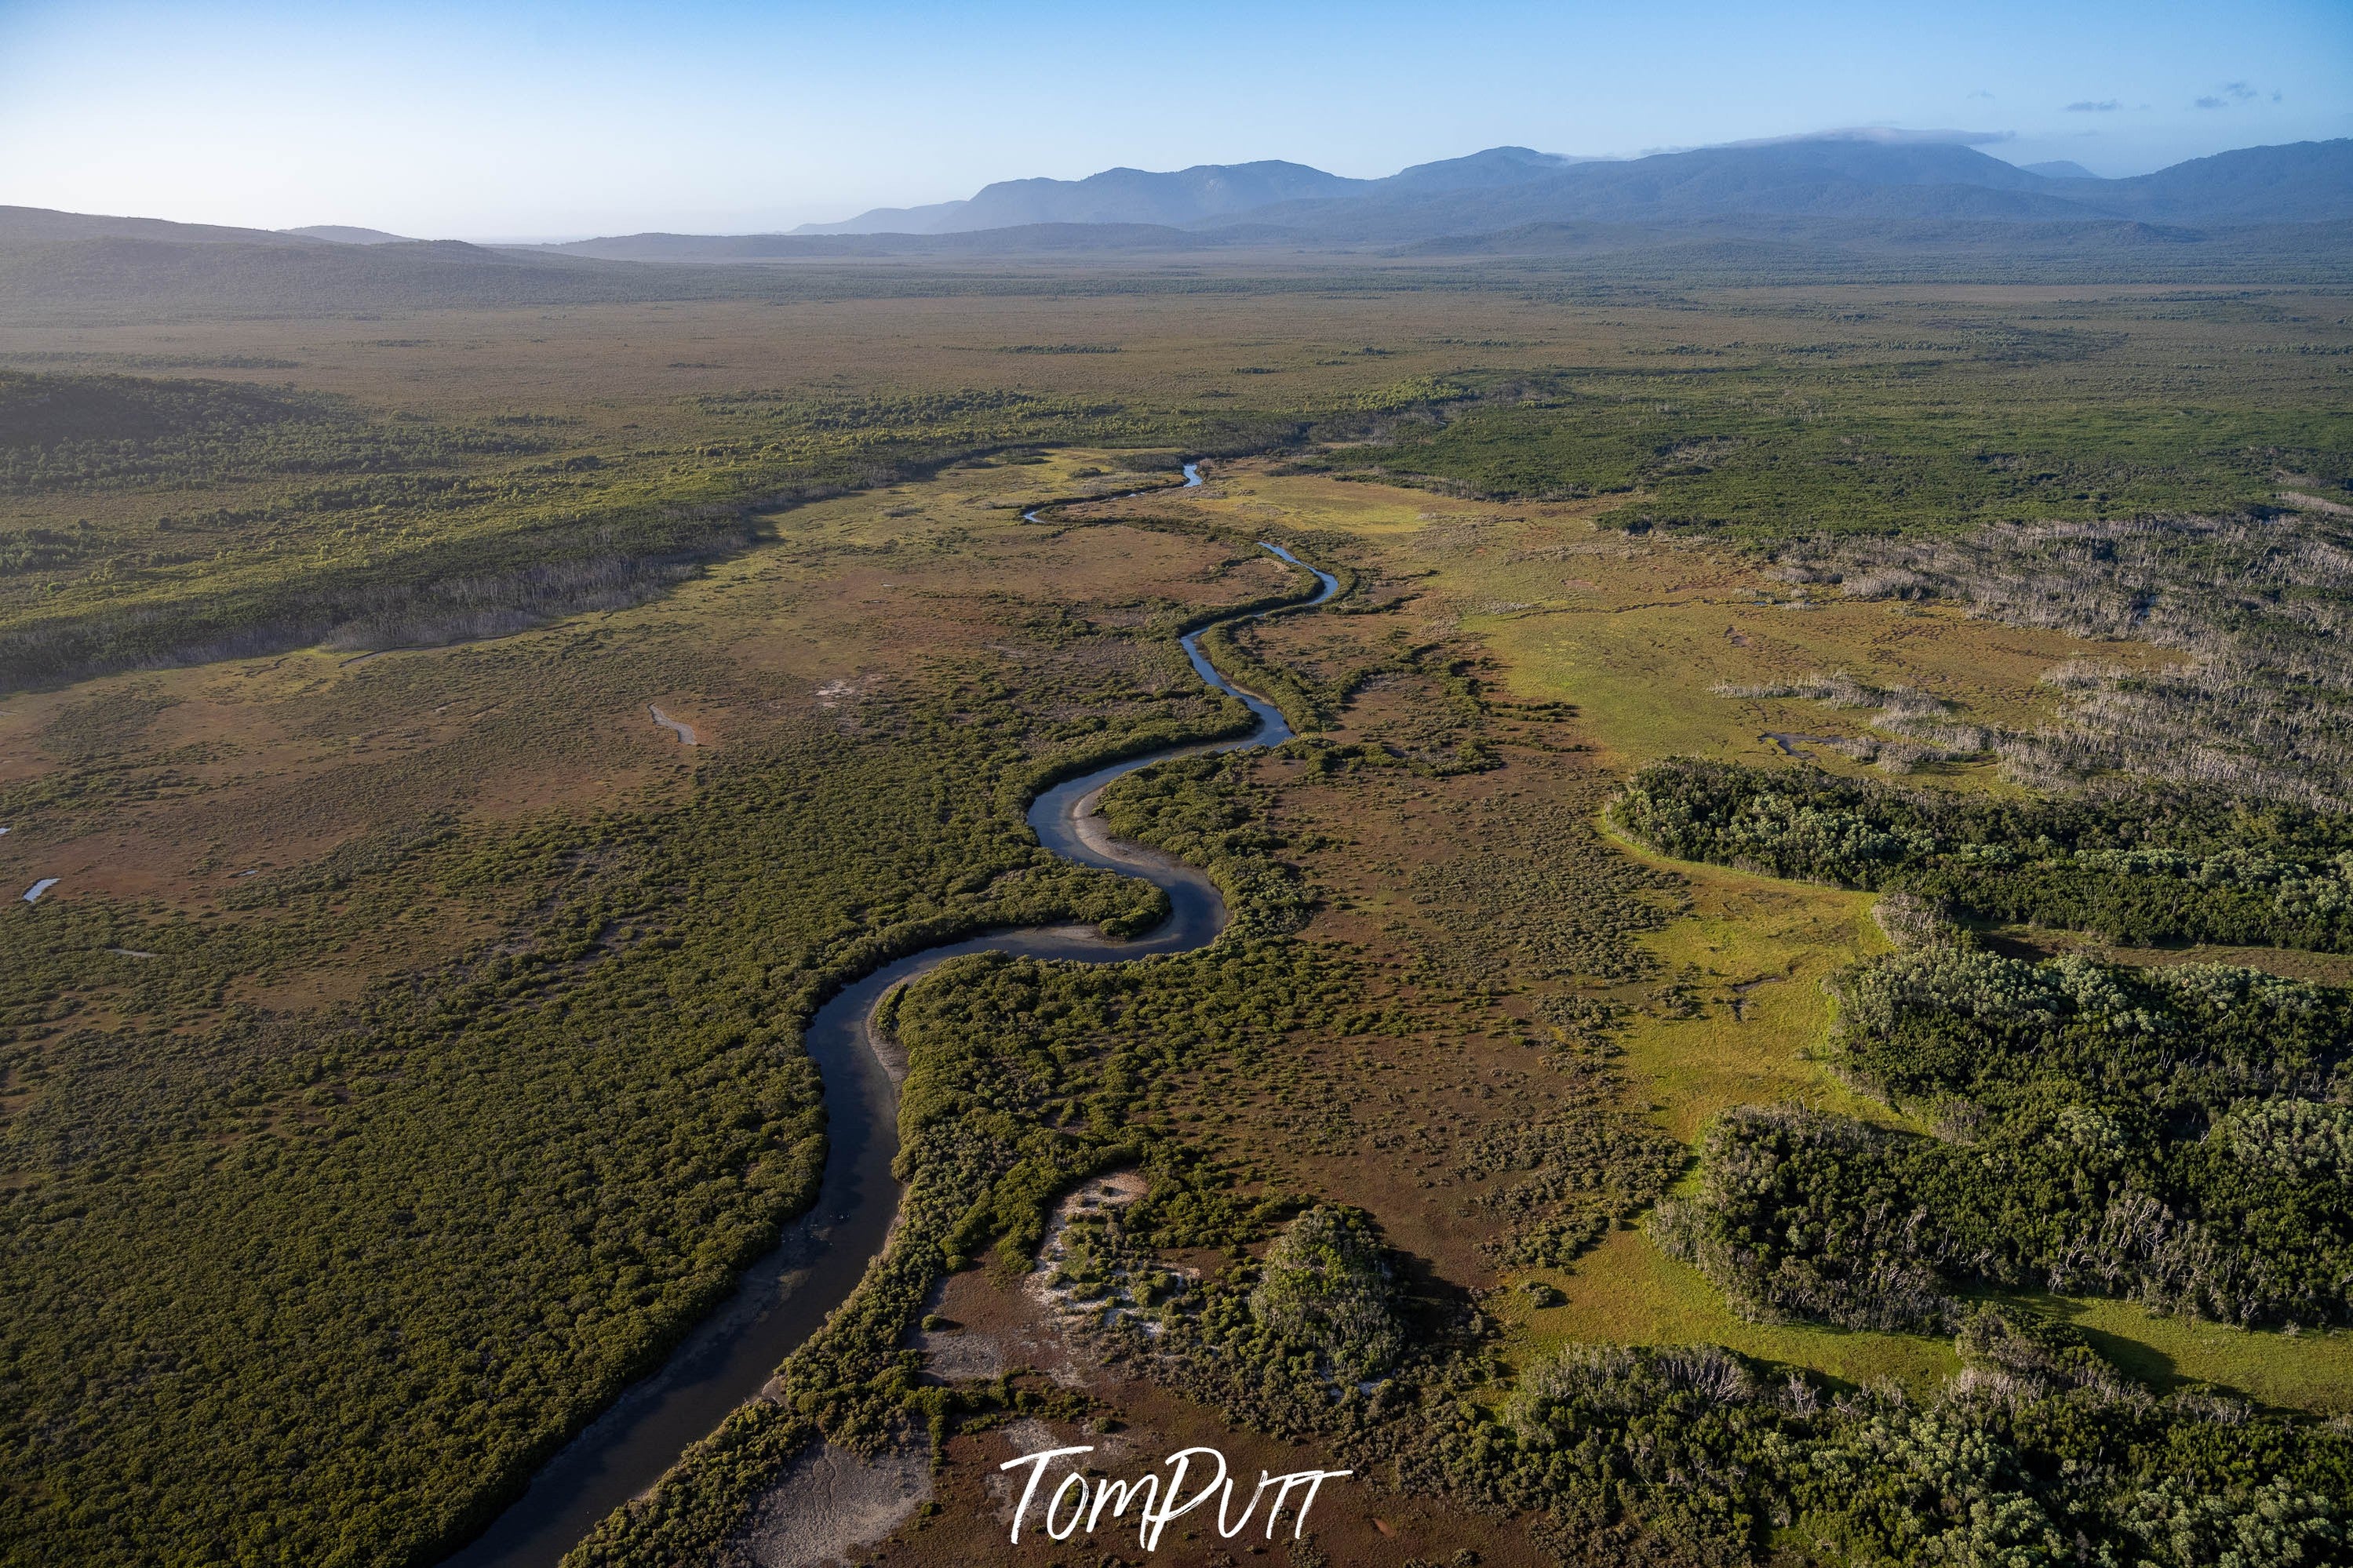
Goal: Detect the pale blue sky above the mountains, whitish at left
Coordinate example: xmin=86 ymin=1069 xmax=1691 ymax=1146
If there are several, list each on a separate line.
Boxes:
xmin=0 ymin=0 xmax=2353 ymax=238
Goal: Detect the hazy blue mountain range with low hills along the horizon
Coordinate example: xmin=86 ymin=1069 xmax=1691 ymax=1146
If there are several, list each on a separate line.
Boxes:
xmin=0 ymin=134 xmax=2353 ymax=320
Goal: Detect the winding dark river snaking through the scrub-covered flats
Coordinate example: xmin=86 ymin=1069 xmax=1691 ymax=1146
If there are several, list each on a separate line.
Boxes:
xmin=447 ymin=463 xmax=1339 ymax=1568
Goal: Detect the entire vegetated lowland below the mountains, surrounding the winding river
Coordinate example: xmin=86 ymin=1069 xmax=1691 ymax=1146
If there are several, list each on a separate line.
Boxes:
xmin=0 ymin=268 xmax=2353 ymax=1566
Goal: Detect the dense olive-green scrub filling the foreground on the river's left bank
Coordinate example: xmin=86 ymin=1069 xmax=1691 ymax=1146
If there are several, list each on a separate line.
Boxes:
xmin=5 ymin=698 xmax=1157 ymax=1561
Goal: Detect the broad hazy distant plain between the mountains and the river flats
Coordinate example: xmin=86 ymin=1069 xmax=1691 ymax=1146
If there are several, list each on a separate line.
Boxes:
xmin=0 ymin=268 xmax=2353 ymax=679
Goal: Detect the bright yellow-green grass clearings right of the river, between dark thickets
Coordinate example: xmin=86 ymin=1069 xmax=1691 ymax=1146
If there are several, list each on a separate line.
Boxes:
xmin=1197 ymin=463 xmax=2353 ymax=1410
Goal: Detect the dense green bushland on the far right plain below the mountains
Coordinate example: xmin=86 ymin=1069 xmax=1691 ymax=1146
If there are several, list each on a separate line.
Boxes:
xmin=1315 ymin=297 xmax=2353 ymax=543
